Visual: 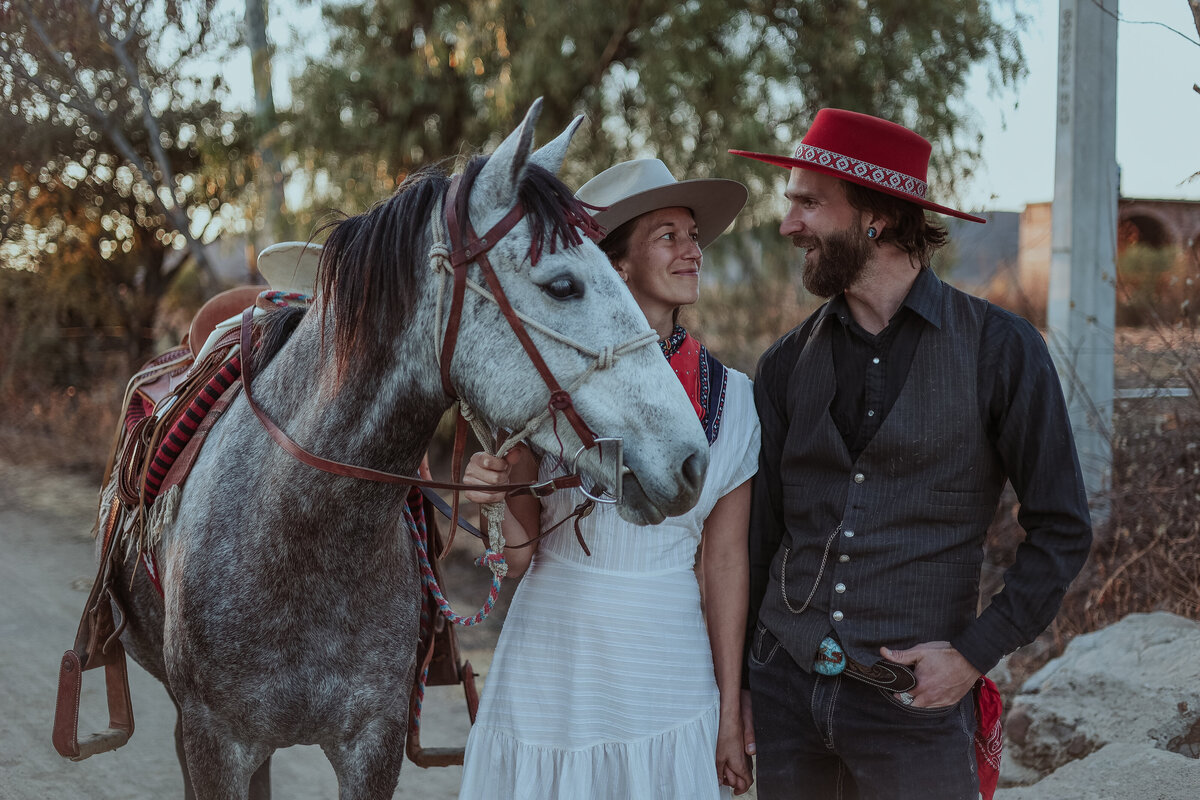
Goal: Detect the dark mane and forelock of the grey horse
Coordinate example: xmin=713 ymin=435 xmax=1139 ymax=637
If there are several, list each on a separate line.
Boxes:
xmin=319 ymin=156 xmax=598 ymax=374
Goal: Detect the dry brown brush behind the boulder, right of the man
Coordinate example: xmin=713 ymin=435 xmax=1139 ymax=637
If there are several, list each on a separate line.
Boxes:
xmin=988 ymin=327 xmax=1200 ymax=688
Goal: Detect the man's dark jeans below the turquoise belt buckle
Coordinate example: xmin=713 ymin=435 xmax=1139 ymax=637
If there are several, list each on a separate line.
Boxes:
xmin=750 ymin=624 xmax=979 ymax=800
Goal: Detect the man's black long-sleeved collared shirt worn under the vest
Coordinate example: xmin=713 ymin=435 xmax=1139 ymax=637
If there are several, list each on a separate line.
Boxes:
xmin=748 ymin=270 xmax=1091 ymax=672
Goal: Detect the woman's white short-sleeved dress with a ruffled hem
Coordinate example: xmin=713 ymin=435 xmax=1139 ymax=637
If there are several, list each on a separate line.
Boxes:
xmin=458 ymin=369 xmax=758 ymax=800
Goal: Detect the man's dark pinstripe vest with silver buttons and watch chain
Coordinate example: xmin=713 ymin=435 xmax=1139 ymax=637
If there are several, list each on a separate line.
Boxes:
xmin=760 ymin=284 xmax=1004 ymax=668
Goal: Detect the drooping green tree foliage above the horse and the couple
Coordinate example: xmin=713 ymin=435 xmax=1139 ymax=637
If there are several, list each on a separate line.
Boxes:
xmin=280 ymin=0 xmax=1024 ymax=225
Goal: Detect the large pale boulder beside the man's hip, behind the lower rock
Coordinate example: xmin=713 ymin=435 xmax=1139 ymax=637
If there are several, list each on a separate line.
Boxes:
xmin=1002 ymin=612 xmax=1200 ymax=777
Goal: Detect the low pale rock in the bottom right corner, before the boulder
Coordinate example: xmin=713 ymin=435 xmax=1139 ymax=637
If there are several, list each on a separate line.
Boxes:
xmin=995 ymin=742 xmax=1200 ymax=800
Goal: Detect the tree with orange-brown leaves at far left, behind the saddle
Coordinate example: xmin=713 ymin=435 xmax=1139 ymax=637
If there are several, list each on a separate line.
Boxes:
xmin=0 ymin=0 xmax=245 ymax=381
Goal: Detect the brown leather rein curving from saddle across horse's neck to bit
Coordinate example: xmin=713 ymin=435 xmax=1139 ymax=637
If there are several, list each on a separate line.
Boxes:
xmin=241 ymin=307 xmax=582 ymax=497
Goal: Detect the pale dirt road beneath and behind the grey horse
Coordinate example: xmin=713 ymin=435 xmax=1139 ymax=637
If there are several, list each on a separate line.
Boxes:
xmin=0 ymin=461 xmax=477 ymax=800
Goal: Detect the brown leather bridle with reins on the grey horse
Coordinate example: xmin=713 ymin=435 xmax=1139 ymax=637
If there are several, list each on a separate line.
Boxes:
xmin=240 ymin=166 xmax=658 ymax=555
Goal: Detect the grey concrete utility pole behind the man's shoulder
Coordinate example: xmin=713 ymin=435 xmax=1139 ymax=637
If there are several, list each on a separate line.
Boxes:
xmin=1046 ymin=0 xmax=1118 ymax=524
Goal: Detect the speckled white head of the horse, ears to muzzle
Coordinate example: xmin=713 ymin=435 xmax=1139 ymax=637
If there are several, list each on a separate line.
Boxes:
xmin=451 ymin=101 xmax=708 ymax=523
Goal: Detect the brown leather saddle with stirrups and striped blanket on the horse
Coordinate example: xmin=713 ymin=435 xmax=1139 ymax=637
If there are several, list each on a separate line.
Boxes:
xmin=53 ymin=287 xmax=479 ymax=768
